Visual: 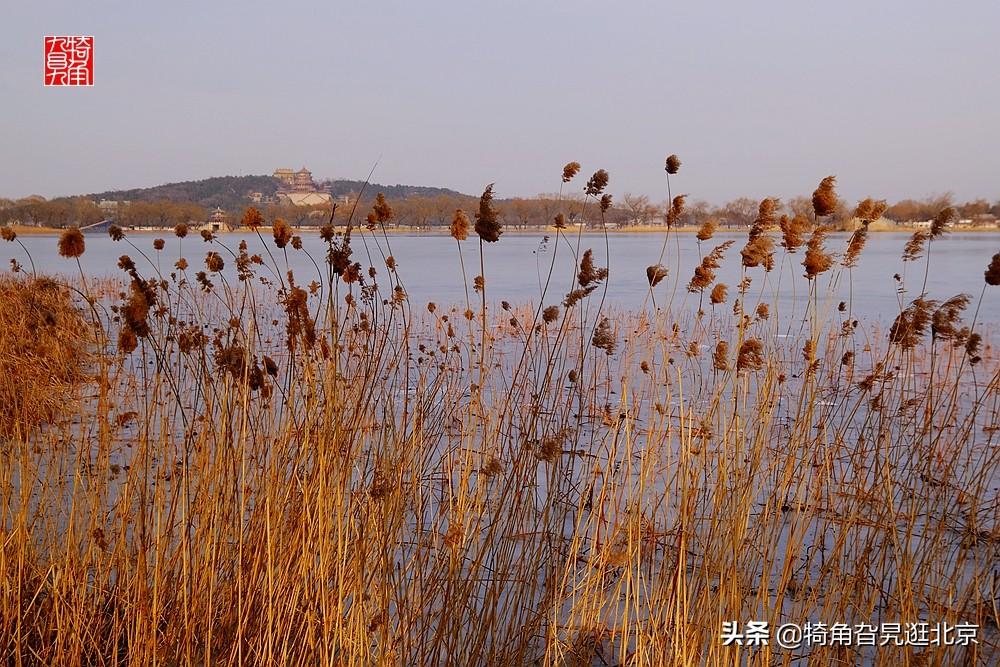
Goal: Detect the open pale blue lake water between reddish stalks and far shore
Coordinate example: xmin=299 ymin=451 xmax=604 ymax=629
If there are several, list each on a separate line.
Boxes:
xmin=7 ymin=230 xmax=1000 ymax=323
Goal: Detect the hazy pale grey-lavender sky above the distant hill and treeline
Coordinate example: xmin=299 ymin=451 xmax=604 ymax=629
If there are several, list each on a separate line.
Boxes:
xmin=0 ymin=0 xmax=1000 ymax=203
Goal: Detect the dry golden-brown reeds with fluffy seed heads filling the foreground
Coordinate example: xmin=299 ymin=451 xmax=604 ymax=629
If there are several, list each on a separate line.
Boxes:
xmin=0 ymin=168 xmax=1000 ymax=665
